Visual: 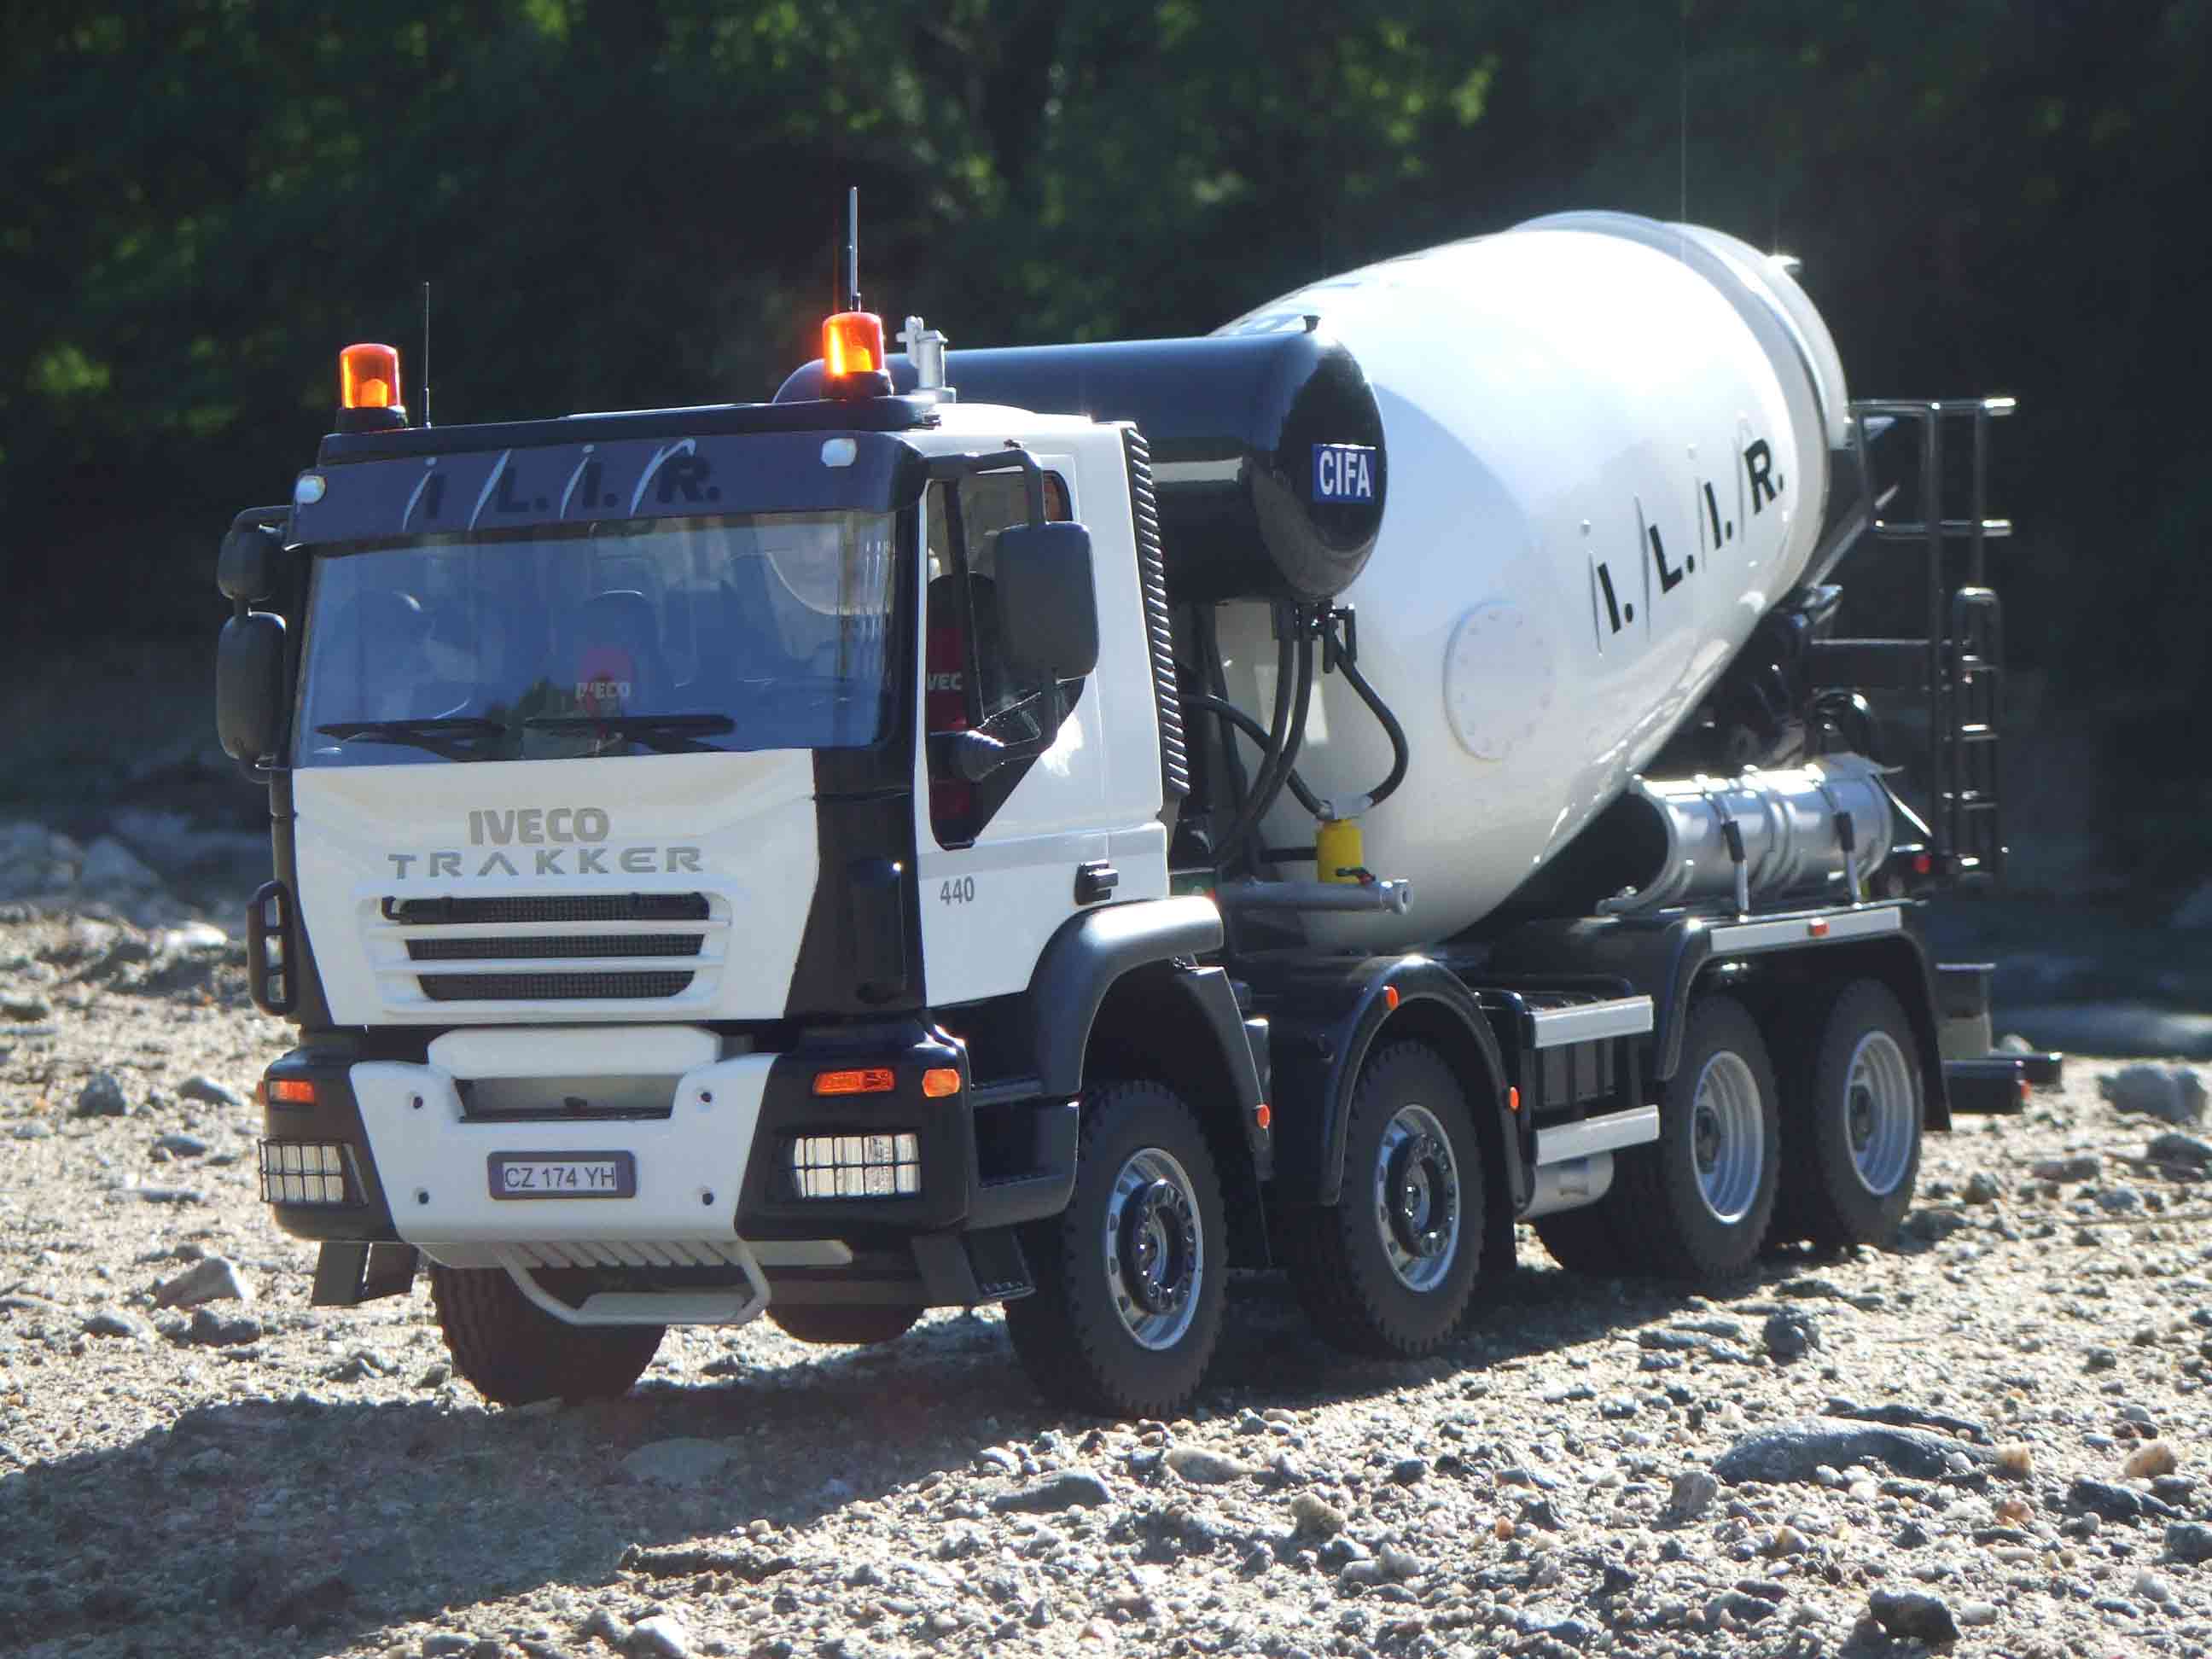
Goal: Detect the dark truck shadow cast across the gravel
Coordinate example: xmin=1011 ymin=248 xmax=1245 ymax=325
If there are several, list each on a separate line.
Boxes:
xmin=0 ymin=1256 xmax=1858 ymax=1655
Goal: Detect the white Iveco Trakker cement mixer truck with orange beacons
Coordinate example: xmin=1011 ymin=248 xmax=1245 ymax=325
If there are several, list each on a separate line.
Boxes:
xmin=219 ymin=204 xmax=2026 ymax=1416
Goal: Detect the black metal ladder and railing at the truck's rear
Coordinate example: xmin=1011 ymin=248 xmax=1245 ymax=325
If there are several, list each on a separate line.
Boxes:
xmin=1816 ymin=399 xmax=2017 ymax=878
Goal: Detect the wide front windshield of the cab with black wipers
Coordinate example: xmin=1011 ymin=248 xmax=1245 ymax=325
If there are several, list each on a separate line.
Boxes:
xmin=296 ymin=513 xmax=894 ymax=765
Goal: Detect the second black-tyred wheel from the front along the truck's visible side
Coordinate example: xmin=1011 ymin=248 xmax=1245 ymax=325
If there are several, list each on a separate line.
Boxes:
xmin=1281 ymin=1042 xmax=1484 ymax=1360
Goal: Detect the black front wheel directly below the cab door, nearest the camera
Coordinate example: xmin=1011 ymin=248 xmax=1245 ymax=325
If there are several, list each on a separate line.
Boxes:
xmin=1006 ymin=1081 xmax=1228 ymax=1417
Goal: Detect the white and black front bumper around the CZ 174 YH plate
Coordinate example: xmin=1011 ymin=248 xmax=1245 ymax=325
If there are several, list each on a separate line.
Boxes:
xmin=263 ymin=1027 xmax=1077 ymax=1323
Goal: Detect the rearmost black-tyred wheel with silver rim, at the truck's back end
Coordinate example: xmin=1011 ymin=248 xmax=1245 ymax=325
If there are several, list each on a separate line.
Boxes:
xmin=1776 ymin=980 xmax=1927 ymax=1248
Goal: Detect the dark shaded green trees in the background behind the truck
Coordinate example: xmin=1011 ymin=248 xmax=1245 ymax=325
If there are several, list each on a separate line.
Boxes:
xmin=0 ymin=0 xmax=2212 ymax=885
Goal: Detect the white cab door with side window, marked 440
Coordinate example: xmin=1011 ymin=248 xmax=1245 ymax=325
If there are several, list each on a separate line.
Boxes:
xmin=913 ymin=453 xmax=1110 ymax=1006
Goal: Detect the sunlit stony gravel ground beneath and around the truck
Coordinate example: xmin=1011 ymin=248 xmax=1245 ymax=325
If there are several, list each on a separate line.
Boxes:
xmin=0 ymin=911 xmax=2212 ymax=1659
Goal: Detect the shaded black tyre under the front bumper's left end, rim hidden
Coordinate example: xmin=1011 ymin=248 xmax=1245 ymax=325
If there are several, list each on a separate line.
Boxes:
xmin=429 ymin=1260 xmax=666 ymax=1405
